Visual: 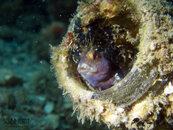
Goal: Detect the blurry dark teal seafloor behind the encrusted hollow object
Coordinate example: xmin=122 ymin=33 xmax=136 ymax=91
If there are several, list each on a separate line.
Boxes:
xmin=0 ymin=0 xmax=108 ymax=130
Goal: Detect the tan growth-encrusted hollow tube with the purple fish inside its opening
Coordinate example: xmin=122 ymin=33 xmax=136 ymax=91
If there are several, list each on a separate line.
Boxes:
xmin=51 ymin=0 xmax=173 ymax=129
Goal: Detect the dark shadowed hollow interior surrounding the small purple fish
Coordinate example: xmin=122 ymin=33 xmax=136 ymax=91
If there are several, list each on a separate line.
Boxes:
xmin=69 ymin=5 xmax=139 ymax=89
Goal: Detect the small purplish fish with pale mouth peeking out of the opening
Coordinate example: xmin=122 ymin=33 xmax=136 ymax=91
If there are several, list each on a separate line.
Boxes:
xmin=77 ymin=51 xmax=115 ymax=90
